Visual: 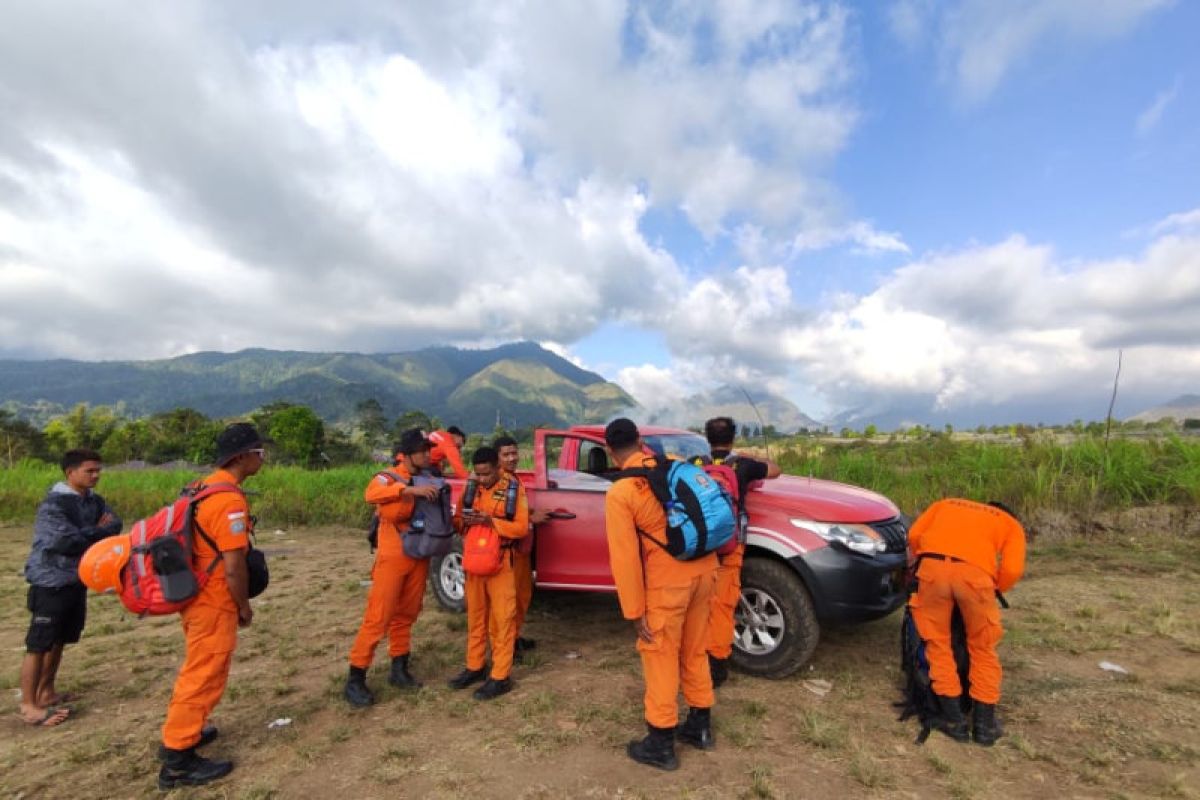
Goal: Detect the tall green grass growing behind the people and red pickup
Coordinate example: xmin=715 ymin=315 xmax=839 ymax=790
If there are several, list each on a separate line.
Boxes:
xmin=0 ymin=437 xmax=1200 ymax=528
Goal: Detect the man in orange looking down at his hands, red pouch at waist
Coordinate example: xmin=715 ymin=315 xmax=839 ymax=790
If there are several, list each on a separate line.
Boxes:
xmin=450 ymin=447 xmax=529 ymax=700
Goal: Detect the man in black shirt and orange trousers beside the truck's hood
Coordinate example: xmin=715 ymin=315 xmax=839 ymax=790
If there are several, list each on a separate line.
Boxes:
xmin=704 ymin=416 xmax=780 ymax=688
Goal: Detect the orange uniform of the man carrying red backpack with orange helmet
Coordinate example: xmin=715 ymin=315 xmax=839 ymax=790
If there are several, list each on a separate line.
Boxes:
xmin=162 ymin=469 xmax=251 ymax=750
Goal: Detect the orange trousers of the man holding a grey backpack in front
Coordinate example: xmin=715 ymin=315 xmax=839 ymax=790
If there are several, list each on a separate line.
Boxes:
xmin=350 ymin=553 xmax=430 ymax=669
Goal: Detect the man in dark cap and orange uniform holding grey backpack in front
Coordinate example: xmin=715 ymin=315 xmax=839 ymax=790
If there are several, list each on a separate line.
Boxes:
xmin=343 ymin=428 xmax=438 ymax=708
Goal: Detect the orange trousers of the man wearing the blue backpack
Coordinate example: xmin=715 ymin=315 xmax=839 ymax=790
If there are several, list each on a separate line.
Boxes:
xmin=637 ymin=572 xmax=715 ymax=728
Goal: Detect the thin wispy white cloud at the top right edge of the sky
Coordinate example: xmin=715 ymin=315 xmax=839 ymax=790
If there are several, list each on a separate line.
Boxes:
xmin=889 ymin=0 xmax=1174 ymax=102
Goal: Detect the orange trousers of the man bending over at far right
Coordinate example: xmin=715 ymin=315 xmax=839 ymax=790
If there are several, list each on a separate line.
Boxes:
xmin=908 ymin=559 xmax=1004 ymax=704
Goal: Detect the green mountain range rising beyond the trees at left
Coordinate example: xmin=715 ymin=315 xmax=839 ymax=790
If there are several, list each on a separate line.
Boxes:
xmin=0 ymin=342 xmax=634 ymax=432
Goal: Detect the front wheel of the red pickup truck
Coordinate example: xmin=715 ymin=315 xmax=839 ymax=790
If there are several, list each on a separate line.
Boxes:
xmin=732 ymin=558 xmax=821 ymax=678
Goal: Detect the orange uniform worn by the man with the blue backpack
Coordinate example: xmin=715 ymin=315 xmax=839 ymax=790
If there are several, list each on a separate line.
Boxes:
xmin=605 ymin=453 xmax=718 ymax=728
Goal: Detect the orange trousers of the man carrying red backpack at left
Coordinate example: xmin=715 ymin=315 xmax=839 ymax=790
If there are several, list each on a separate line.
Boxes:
xmin=162 ymin=599 xmax=238 ymax=750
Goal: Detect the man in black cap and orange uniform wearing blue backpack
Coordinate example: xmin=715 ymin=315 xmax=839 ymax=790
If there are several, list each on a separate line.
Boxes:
xmin=604 ymin=417 xmax=718 ymax=770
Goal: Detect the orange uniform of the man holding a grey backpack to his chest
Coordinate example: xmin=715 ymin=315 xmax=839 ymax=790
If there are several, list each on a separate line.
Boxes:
xmin=350 ymin=465 xmax=430 ymax=669
